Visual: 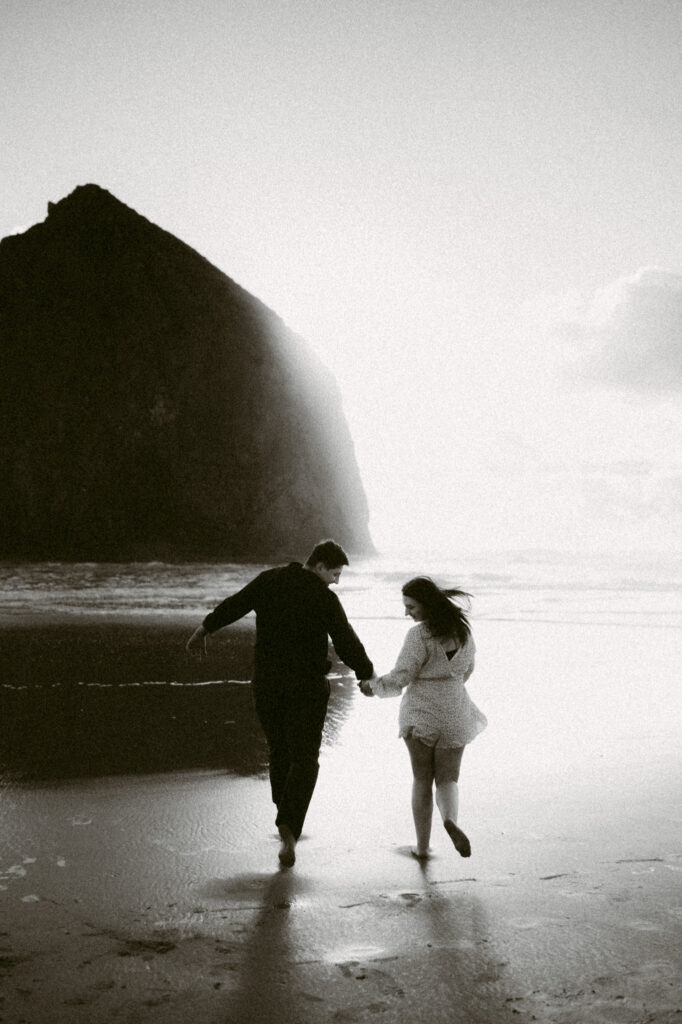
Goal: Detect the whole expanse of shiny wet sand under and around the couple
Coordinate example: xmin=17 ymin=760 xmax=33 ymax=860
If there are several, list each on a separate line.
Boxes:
xmin=0 ymin=621 xmax=682 ymax=1024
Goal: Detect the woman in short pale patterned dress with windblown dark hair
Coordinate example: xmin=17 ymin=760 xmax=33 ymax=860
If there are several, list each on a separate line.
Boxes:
xmin=360 ymin=577 xmax=487 ymax=859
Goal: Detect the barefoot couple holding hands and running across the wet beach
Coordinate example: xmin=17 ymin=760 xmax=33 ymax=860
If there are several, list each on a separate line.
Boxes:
xmin=186 ymin=541 xmax=486 ymax=867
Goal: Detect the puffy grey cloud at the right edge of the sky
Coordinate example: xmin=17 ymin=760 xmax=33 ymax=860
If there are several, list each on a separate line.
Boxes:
xmin=554 ymin=267 xmax=682 ymax=395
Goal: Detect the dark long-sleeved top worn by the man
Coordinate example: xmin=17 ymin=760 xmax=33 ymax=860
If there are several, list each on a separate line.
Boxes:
xmin=204 ymin=562 xmax=374 ymax=683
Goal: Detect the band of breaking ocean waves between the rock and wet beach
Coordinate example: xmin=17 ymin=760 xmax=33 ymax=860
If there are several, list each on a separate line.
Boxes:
xmin=0 ymin=552 xmax=682 ymax=629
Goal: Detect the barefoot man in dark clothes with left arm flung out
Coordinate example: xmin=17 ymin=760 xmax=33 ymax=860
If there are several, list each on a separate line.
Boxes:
xmin=186 ymin=541 xmax=374 ymax=867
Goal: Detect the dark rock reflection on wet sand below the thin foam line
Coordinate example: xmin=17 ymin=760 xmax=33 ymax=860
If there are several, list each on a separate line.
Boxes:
xmin=0 ymin=682 xmax=267 ymax=780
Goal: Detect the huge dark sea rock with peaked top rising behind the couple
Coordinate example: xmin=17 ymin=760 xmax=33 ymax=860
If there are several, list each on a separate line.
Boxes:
xmin=0 ymin=185 xmax=372 ymax=561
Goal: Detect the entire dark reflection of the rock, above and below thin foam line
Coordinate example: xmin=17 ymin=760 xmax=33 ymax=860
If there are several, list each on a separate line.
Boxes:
xmin=0 ymin=621 xmax=353 ymax=779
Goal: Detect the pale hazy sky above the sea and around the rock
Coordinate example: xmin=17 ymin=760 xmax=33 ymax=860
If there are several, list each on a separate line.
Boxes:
xmin=0 ymin=0 xmax=682 ymax=552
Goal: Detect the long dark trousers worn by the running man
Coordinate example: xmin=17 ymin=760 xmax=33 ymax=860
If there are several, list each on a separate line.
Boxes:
xmin=254 ymin=676 xmax=330 ymax=840
